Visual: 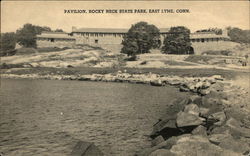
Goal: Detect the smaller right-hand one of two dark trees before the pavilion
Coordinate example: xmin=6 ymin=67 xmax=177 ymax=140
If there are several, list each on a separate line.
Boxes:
xmin=162 ymin=26 xmax=192 ymax=54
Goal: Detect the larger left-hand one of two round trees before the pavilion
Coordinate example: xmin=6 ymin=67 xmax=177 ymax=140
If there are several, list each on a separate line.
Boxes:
xmin=121 ymin=22 xmax=160 ymax=57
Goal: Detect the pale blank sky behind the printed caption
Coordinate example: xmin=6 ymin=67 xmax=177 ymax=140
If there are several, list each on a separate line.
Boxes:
xmin=1 ymin=1 xmax=250 ymax=32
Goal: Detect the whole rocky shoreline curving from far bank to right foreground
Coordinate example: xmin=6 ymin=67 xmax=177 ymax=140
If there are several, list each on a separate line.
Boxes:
xmin=1 ymin=71 xmax=250 ymax=156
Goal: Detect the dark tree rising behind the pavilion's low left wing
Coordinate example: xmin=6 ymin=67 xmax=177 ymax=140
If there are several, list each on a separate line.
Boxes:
xmin=16 ymin=24 xmax=51 ymax=48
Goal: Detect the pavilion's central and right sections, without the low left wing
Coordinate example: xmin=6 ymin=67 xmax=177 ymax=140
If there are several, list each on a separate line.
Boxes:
xmin=71 ymin=27 xmax=235 ymax=54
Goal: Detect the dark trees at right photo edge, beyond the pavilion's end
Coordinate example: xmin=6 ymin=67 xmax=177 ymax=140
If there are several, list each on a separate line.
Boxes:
xmin=227 ymin=27 xmax=250 ymax=43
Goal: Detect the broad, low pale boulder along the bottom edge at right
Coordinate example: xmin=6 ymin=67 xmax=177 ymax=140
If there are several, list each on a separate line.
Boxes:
xmin=170 ymin=135 xmax=241 ymax=156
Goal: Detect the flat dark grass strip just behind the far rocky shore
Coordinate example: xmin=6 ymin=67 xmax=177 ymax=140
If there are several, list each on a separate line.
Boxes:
xmin=1 ymin=67 xmax=249 ymax=79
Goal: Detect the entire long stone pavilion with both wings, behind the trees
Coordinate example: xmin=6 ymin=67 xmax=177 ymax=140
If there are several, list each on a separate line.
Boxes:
xmin=37 ymin=27 xmax=236 ymax=54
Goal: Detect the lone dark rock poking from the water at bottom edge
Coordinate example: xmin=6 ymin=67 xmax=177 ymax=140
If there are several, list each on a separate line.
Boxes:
xmin=70 ymin=141 xmax=104 ymax=156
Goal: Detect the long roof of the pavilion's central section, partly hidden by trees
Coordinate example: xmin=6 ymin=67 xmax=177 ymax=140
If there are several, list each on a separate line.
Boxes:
xmin=72 ymin=28 xmax=169 ymax=33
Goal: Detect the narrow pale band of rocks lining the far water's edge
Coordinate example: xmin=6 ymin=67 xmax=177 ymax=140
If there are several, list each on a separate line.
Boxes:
xmin=1 ymin=71 xmax=226 ymax=95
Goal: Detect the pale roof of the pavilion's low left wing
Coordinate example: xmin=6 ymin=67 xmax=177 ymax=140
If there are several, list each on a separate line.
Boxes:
xmin=36 ymin=32 xmax=75 ymax=39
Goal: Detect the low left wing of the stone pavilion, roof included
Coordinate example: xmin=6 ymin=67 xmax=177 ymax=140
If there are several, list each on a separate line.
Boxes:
xmin=36 ymin=32 xmax=76 ymax=48
